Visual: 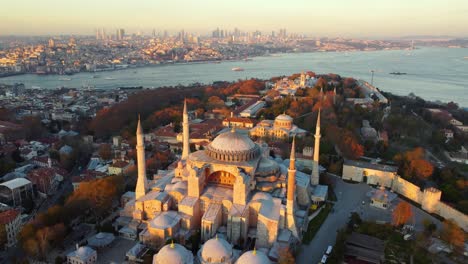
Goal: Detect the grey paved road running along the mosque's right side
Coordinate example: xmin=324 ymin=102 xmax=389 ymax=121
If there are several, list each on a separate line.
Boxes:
xmin=296 ymin=177 xmax=371 ymax=264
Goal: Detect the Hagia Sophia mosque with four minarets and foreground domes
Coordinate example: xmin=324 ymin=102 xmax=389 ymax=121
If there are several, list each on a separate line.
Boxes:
xmin=119 ymin=100 xmax=326 ymax=264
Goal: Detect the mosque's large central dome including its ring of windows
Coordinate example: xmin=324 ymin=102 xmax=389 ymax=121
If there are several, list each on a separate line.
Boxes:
xmin=207 ymin=130 xmax=260 ymax=161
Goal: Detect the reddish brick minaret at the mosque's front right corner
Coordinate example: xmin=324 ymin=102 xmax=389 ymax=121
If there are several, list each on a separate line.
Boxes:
xmin=286 ymin=137 xmax=299 ymax=237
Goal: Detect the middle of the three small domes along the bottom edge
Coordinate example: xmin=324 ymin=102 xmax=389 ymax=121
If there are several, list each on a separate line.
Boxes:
xmin=201 ymin=237 xmax=233 ymax=263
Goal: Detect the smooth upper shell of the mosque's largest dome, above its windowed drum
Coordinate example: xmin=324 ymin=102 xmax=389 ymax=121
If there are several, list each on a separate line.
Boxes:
xmin=210 ymin=131 xmax=256 ymax=151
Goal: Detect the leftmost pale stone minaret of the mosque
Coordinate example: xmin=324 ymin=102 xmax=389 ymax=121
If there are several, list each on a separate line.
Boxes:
xmin=135 ymin=116 xmax=148 ymax=200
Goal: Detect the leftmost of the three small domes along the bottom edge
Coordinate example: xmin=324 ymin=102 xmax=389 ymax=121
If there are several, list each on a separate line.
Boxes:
xmin=153 ymin=243 xmax=193 ymax=264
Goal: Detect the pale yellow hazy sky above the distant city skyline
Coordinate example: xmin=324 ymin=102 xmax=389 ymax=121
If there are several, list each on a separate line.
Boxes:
xmin=0 ymin=0 xmax=468 ymax=38
